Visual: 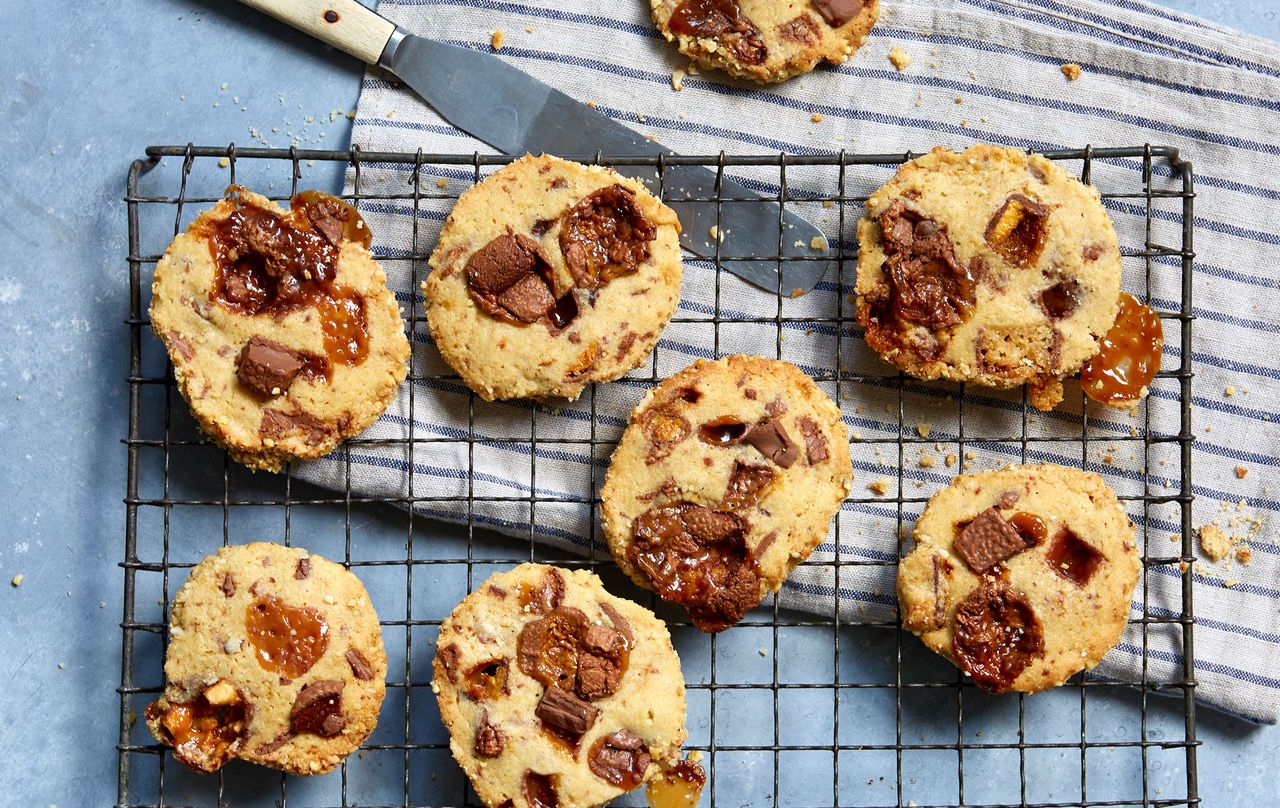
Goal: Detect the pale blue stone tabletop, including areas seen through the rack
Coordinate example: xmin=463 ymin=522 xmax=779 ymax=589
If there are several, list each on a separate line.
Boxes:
xmin=0 ymin=0 xmax=1280 ymax=808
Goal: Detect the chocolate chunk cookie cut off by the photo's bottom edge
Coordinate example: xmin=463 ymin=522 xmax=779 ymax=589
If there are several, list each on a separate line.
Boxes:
xmin=431 ymin=563 xmax=685 ymax=808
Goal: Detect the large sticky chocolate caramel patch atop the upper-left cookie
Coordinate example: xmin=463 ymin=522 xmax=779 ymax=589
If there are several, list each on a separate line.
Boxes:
xmin=204 ymin=187 xmax=371 ymax=378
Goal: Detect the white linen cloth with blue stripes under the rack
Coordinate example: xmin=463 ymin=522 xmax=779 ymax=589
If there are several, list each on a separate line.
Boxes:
xmin=301 ymin=0 xmax=1280 ymax=722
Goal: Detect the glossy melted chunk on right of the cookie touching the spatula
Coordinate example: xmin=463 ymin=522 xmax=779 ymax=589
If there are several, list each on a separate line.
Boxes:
xmin=559 ymin=184 xmax=658 ymax=289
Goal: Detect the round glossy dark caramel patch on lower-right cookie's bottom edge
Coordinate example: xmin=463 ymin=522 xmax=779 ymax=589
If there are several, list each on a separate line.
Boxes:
xmin=951 ymin=578 xmax=1044 ymax=693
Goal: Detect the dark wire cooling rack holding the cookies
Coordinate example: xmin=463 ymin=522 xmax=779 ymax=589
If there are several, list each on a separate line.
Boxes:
xmin=118 ymin=145 xmax=1199 ymax=808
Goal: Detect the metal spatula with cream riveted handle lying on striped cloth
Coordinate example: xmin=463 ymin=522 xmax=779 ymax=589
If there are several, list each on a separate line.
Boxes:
xmin=242 ymin=0 xmax=829 ymax=296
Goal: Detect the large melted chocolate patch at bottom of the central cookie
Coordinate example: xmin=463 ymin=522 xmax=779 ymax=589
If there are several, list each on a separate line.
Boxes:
xmin=627 ymin=502 xmax=760 ymax=633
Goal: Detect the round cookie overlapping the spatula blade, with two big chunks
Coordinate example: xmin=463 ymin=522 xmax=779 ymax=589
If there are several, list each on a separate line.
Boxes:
xmin=422 ymin=155 xmax=682 ymax=401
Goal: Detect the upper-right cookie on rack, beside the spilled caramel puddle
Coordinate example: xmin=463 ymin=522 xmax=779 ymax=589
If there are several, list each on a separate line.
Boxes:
xmin=856 ymin=146 xmax=1120 ymax=410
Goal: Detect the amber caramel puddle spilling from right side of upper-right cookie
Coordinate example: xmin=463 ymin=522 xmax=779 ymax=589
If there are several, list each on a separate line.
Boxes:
xmin=1080 ymin=292 xmax=1165 ymax=406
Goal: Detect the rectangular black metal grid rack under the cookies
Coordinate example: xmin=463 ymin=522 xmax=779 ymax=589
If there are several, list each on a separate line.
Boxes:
xmin=118 ymin=145 xmax=1199 ymax=808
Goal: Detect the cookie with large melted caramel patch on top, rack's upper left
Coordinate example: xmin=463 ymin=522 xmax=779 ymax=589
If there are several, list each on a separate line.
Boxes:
xmin=151 ymin=187 xmax=410 ymax=471
